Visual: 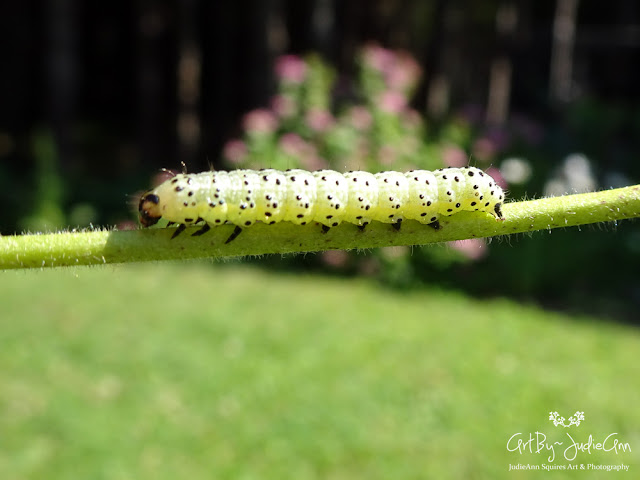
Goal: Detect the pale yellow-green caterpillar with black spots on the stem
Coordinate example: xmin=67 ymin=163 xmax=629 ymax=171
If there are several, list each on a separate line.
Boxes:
xmin=138 ymin=167 xmax=504 ymax=243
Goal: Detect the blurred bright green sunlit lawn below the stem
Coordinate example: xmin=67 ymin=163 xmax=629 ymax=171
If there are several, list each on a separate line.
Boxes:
xmin=0 ymin=264 xmax=640 ymax=480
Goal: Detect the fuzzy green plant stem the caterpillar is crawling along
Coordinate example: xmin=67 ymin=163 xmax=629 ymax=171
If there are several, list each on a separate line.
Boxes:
xmin=0 ymin=185 xmax=640 ymax=269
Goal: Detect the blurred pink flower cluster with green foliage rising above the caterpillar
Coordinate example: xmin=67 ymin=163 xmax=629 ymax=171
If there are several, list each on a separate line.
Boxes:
xmin=223 ymin=44 xmax=436 ymax=176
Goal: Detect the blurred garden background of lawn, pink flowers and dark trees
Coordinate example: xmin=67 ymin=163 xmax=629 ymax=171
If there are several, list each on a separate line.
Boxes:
xmin=0 ymin=0 xmax=640 ymax=478
